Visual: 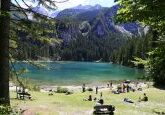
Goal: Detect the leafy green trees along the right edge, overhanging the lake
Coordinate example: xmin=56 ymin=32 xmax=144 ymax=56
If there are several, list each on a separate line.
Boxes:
xmin=116 ymin=0 xmax=165 ymax=85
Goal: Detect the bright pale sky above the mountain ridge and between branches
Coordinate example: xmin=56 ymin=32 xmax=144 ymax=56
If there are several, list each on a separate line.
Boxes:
xmin=12 ymin=0 xmax=115 ymax=10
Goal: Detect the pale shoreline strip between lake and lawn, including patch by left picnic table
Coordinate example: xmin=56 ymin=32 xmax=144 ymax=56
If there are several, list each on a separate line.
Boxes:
xmin=9 ymin=80 xmax=153 ymax=92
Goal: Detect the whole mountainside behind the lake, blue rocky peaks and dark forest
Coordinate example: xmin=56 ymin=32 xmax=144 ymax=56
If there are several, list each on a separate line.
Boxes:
xmin=13 ymin=4 xmax=148 ymax=65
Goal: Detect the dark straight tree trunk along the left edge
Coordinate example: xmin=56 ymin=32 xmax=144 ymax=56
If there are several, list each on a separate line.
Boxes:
xmin=0 ymin=0 xmax=10 ymax=105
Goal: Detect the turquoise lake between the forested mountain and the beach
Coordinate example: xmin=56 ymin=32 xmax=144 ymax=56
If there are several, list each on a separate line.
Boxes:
xmin=15 ymin=61 xmax=144 ymax=85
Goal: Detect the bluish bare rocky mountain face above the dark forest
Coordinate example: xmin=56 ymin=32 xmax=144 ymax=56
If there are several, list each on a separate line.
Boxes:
xmin=56 ymin=5 xmax=143 ymax=42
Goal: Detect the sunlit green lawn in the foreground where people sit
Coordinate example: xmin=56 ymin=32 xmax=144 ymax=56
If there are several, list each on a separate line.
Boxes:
xmin=11 ymin=88 xmax=165 ymax=115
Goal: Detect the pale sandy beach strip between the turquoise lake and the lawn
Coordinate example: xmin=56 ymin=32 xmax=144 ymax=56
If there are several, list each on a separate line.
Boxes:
xmin=40 ymin=80 xmax=153 ymax=92
